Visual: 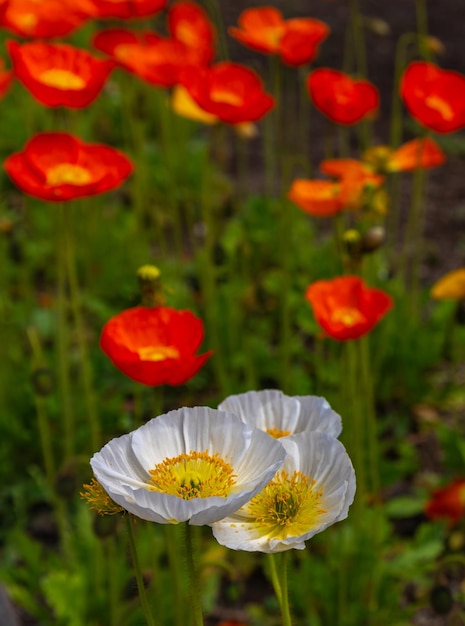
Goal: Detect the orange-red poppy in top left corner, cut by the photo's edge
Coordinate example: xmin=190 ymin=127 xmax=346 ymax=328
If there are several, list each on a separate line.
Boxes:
xmin=2 ymin=0 xmax=95 ymax=39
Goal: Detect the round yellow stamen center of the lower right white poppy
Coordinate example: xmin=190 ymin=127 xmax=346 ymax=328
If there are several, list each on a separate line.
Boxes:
xmin=246 ymin=470 xmax=326 ymax=539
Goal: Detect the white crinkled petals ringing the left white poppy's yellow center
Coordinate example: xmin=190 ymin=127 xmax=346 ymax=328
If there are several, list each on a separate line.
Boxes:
xmin=91 ymin=407 xmax=286 ymax=525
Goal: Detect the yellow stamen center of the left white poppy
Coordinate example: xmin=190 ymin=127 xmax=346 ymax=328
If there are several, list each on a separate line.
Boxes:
xmin=149 ymin=450 xmax=236 ymax=500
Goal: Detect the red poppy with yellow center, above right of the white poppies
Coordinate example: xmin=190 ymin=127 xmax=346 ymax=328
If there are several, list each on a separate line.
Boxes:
xmin=305 ymin=276 xmax=392 ymax=341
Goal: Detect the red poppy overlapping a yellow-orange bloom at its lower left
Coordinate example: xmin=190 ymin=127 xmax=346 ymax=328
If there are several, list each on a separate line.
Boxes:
xmin=181 ymin=61 xmax=274 ymax=124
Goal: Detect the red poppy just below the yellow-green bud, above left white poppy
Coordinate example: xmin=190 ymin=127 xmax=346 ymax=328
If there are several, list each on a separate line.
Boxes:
xmin=100 ymin=306 xmax=212 ymax=386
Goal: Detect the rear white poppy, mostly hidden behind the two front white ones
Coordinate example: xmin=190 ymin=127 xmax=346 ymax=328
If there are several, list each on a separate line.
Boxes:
xmin=218 ymin=389 xmax=342 ymax=438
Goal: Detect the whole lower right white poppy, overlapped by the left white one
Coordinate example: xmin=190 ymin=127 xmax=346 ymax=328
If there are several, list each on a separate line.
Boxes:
xmin=212 ymin=431 xmax=355 ymax=552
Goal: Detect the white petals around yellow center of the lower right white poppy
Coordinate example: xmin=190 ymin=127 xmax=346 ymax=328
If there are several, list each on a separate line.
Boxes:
xmin=212 ymin=431 xmax=356 ymax=552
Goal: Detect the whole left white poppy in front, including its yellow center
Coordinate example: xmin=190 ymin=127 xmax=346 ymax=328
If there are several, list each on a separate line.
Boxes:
xmin=90 ymin=407 xmax=286 ymax=526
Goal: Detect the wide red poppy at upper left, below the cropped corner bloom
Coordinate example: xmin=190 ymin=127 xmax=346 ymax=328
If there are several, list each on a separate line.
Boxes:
xmin=7 ymin=41 xmax=115 ymax=109
